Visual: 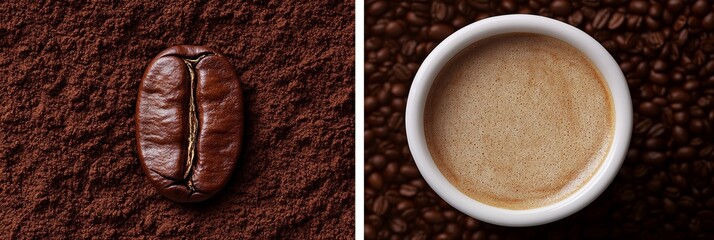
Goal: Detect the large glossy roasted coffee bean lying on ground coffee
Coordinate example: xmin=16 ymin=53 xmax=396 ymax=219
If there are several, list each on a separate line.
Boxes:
xmin=135 ymin=45 xmax=243 ymax=202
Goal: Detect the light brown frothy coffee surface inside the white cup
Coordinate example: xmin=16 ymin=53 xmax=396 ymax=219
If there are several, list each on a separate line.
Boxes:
xmin=424 ymin=33 xmax=614 ymax=209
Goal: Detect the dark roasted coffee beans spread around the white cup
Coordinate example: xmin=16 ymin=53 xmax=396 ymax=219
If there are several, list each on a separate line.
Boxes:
xmin=364 ymin=0 xmax=714 ymax=239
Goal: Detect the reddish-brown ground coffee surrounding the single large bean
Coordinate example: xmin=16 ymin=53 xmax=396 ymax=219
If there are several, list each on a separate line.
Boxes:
xmin=0 ymin=0 xmax=355 ymax=239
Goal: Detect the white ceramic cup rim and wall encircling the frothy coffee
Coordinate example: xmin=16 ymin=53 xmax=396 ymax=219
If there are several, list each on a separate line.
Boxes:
xmin=406 ymin=14 xmax=632 ymax=227
